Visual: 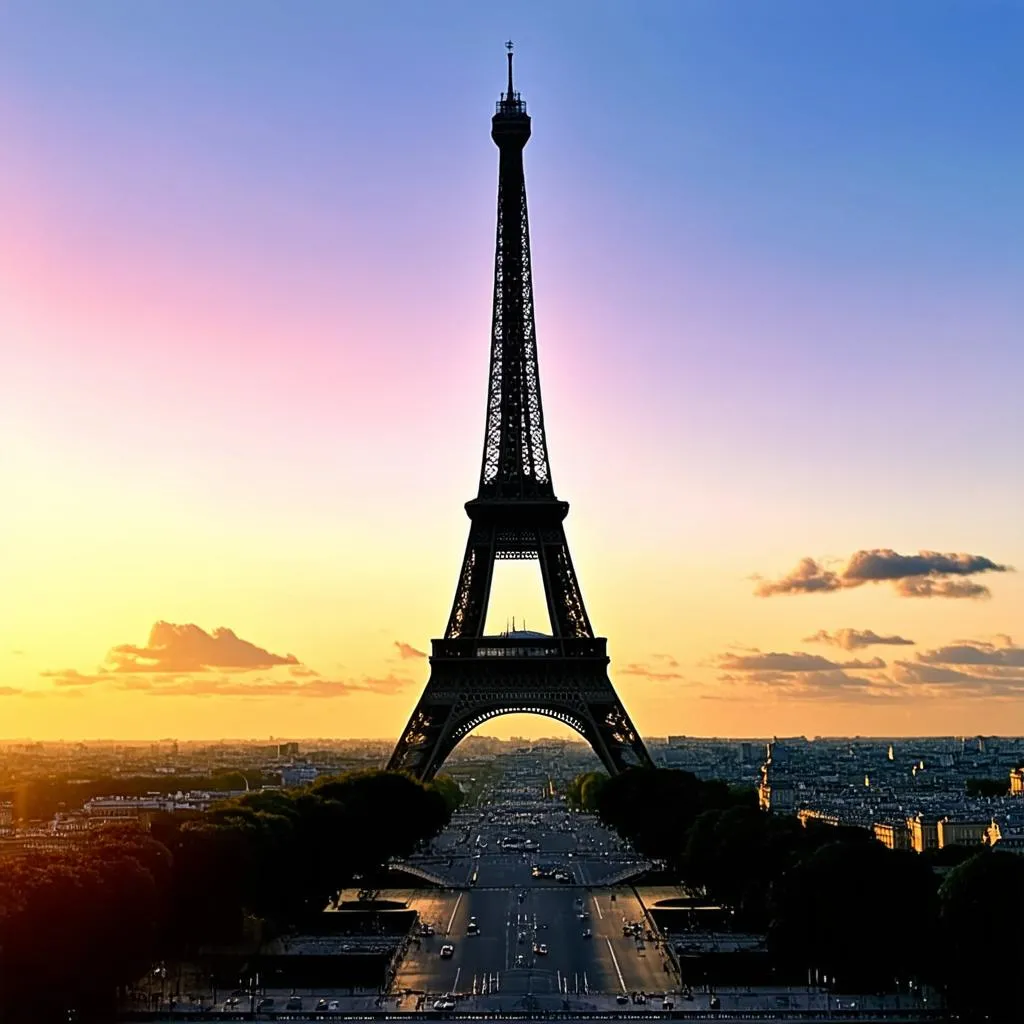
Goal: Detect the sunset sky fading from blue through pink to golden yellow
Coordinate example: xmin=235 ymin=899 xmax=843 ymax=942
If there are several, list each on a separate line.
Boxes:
xmin=0 ymin=0 xmax=1024 ymax=738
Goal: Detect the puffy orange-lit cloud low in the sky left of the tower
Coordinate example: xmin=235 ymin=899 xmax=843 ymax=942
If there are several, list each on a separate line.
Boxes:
xmin=108 ymin=622 xmax=299 ymax=672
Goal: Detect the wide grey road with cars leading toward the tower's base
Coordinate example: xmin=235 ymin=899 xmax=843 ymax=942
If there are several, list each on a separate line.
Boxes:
xmin=391 ymin=761 xmax=677 ymax=1009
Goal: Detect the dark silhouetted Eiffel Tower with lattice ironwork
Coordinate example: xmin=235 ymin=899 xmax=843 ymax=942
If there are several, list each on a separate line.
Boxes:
xmin=388 ymin=43 xmax=651 ymax=780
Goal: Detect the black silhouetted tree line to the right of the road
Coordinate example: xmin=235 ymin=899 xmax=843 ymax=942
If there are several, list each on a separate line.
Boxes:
xmin=568 ymin=768 xmax=1024 ymax=1019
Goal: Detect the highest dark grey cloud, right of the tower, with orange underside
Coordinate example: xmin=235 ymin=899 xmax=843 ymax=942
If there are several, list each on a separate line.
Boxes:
xmin=754 ymin=548 xmax=1013 ymax=598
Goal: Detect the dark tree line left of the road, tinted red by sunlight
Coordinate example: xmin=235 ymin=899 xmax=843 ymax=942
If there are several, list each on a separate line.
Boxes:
xmin=0 ymin=771 xmax=461 ymax=1024
